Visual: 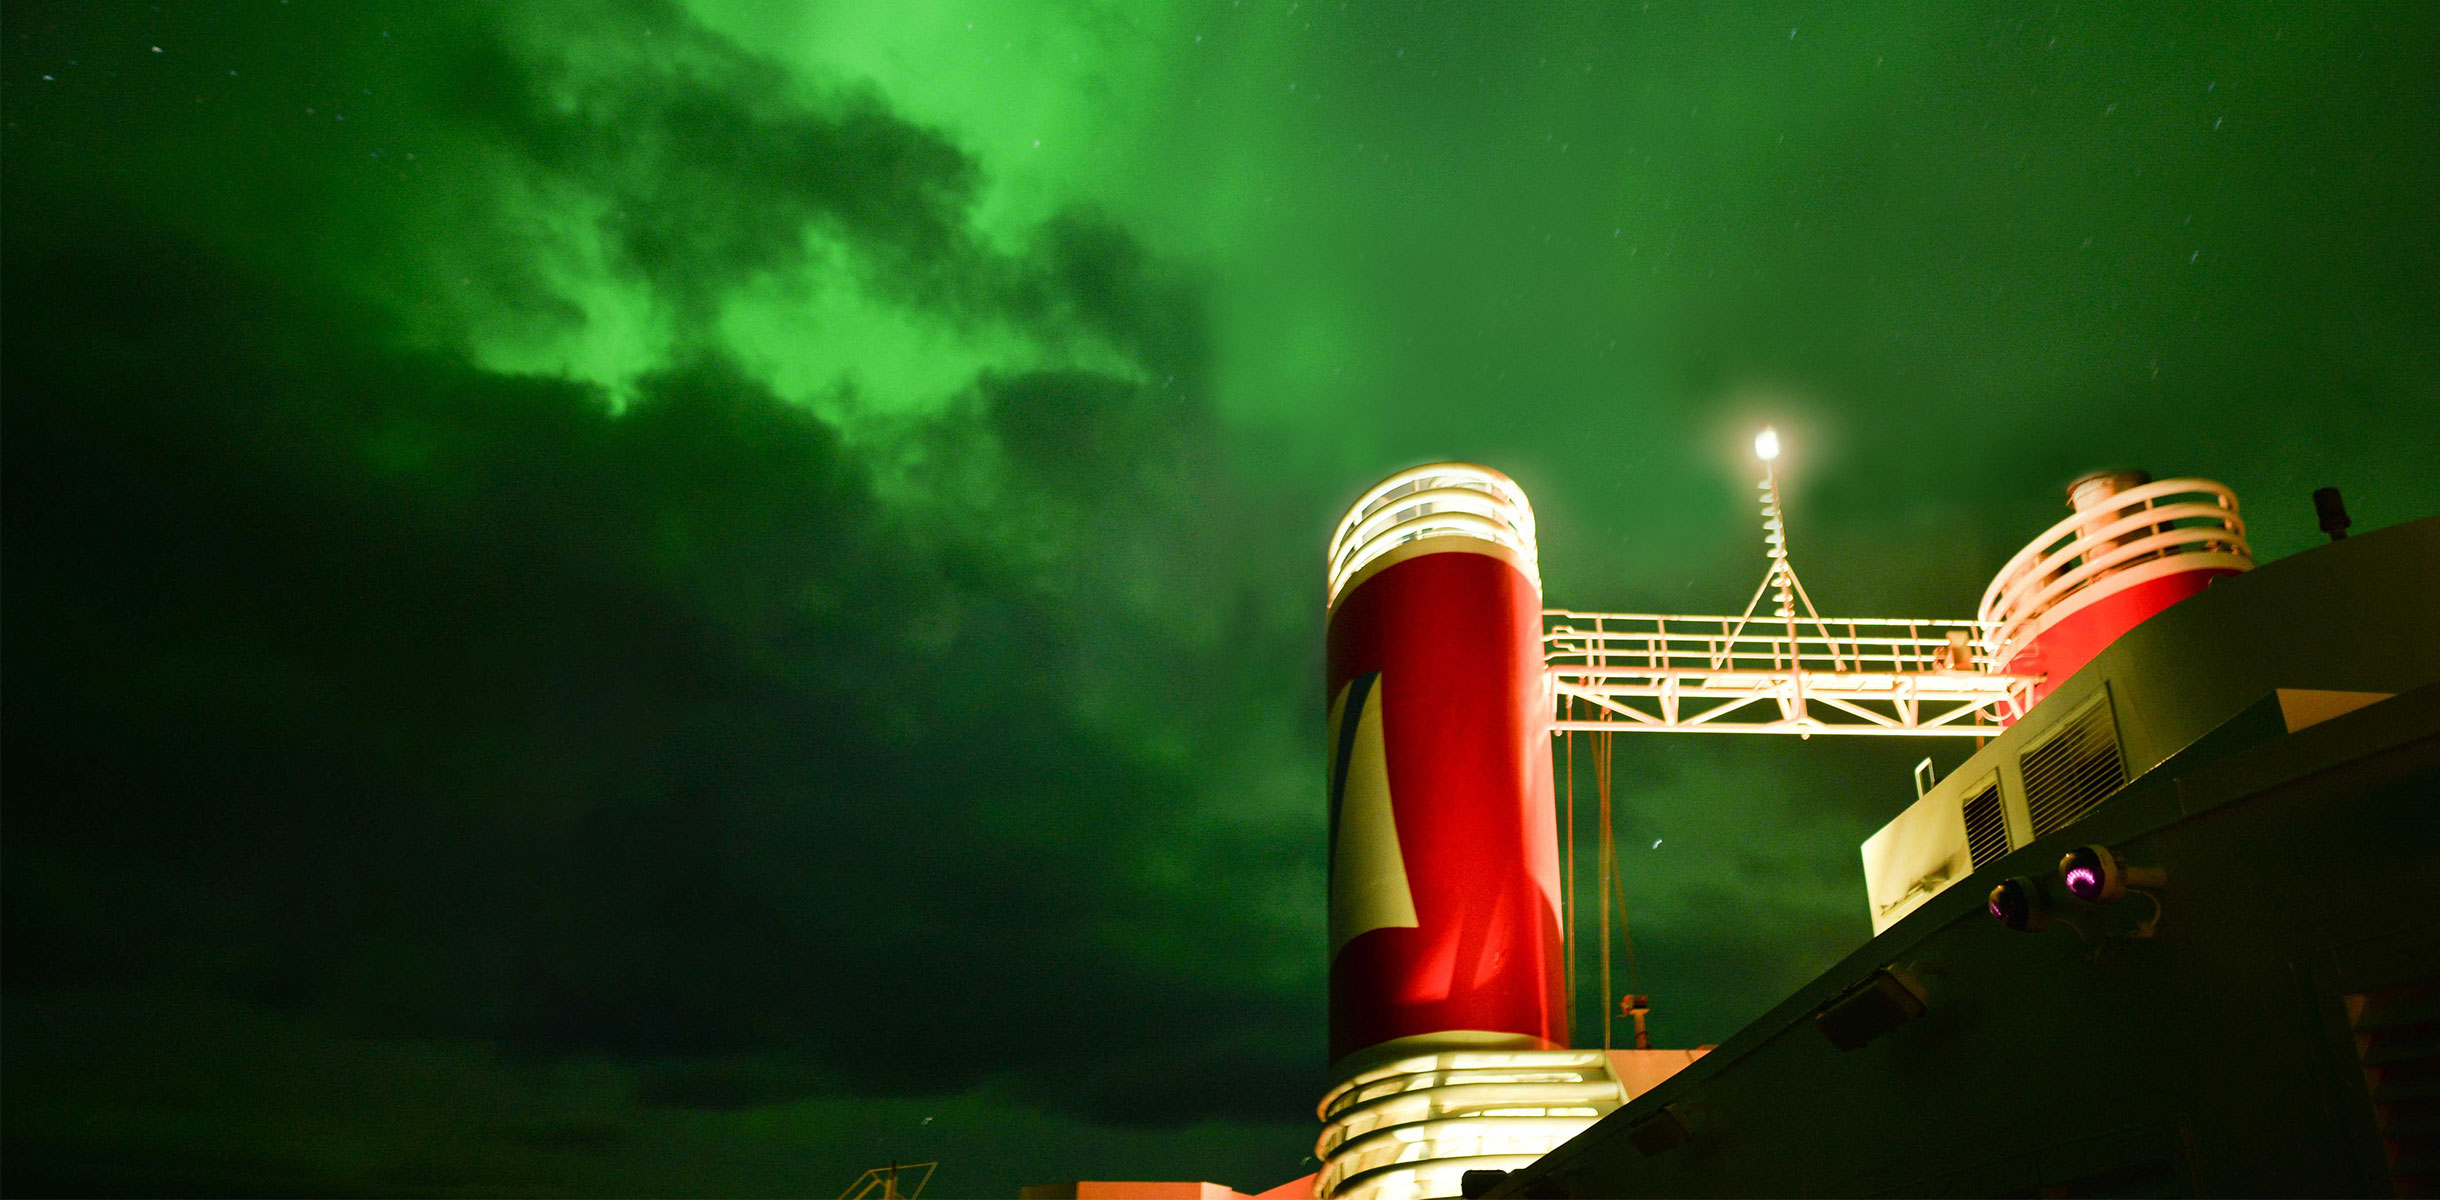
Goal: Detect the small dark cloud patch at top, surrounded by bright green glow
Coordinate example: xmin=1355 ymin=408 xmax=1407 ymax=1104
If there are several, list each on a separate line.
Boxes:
xmin=429 ymin=5 xmax=981 ymax=317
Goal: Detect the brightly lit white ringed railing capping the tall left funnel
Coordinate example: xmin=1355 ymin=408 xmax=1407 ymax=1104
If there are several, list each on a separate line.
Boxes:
xmin=1327 ymin=463 xmax=1542 ymax=605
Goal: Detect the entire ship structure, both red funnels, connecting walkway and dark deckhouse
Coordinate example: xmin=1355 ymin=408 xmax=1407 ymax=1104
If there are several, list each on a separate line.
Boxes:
xmin=1030 ymin=441 xmax=2440 ymax=1200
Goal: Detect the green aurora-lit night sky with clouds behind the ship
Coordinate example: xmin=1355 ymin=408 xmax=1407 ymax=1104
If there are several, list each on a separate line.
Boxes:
xmin=0 ymin=0 xmax=2440 ymax=1195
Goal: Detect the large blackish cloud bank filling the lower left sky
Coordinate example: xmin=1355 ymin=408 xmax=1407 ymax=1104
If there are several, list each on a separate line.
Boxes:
xmin=7 ymin=213 xmax=1298 ymax=1120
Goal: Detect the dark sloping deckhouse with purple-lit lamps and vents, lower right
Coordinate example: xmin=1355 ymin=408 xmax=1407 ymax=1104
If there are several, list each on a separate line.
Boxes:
xmin=1464 ymin=517 xmax=2440 ymax=1198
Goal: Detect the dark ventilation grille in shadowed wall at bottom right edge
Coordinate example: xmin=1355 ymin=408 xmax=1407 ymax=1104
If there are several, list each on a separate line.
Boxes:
xmin=2347 ymin=980 xmax=2440 ymax=1195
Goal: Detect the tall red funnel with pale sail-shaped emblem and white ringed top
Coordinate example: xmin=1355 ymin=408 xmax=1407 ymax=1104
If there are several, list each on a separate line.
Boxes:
xmin=1325 ymin=463 xmax=1566 ymax=1076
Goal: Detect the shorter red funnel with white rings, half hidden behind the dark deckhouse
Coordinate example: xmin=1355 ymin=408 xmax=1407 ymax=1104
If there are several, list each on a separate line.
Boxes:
xmin=1979 ymin=471 xmax=2255 ymax=717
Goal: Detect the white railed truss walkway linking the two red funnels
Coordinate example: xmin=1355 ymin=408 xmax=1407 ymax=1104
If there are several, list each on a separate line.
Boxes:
xmin=1542 ymin=610 xmax=2042 ymax=737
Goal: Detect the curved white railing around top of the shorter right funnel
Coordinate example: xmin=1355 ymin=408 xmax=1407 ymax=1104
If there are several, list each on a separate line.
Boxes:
xmin=1976 ymin=478 xmax=2255 ymax=663
